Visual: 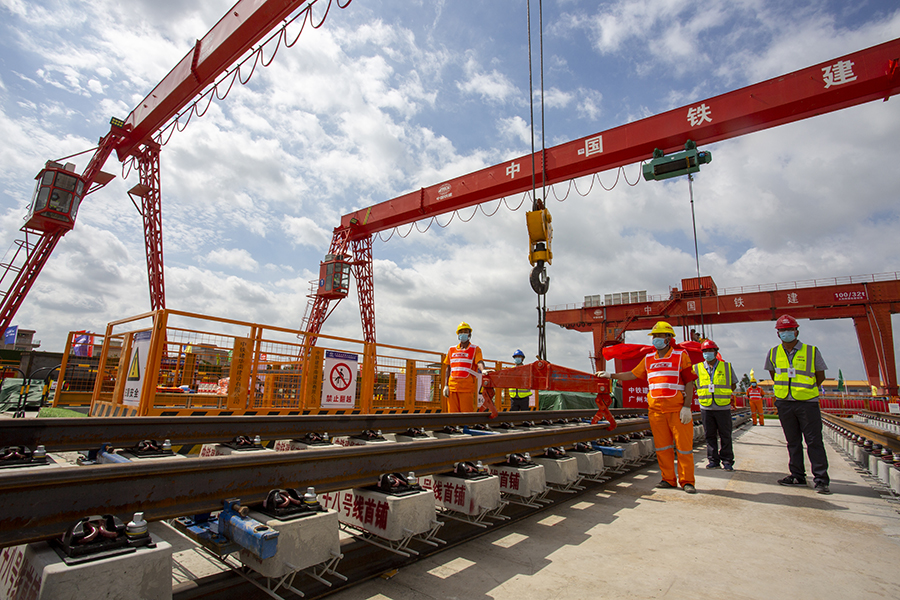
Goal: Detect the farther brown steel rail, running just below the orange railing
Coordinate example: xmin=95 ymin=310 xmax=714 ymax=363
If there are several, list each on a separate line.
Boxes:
xmin=0 ymin=409 xmax=647 ymax=452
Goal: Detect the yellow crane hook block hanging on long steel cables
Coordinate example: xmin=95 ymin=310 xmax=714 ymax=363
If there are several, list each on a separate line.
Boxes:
xmin=525 ymin=0 xmax=553 ymax=361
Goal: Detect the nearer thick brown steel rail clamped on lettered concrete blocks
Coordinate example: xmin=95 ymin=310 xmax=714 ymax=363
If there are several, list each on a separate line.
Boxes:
xmin=0 ymin=419 xmax=648 ymax=548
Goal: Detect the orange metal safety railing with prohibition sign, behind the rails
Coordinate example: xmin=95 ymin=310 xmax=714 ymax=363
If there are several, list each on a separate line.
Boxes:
xmin=84 ymin=310 xmax=509 ymax=416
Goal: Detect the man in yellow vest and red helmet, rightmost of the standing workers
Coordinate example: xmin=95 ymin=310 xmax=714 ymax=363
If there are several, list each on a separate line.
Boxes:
xmin=765 ymin=315 xmax=831 ymax=494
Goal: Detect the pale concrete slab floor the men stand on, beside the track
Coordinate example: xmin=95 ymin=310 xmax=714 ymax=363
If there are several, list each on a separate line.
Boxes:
xmin=330 ymin=421 xmax=900 ymax=600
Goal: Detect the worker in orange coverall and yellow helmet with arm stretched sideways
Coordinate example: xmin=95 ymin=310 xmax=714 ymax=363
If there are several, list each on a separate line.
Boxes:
xmin=597 ymin=321 xmax=697 ymax=494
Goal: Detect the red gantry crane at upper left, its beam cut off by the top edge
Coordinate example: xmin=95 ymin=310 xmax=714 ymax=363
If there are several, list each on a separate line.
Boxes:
xmin=0 ymin=0 xmax=352 ymax=332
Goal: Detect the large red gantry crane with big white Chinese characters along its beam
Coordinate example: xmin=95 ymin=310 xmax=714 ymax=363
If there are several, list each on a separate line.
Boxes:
xmin=301 ymin=39 xmax=900 ymax=352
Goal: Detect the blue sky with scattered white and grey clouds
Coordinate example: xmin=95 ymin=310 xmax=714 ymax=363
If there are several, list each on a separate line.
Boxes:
xmin=0 ymin=0 xmax=900 ymax=379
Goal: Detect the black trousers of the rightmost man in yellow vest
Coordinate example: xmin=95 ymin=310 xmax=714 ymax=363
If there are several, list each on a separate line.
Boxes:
xmin=775 ymin=400 xmax=830 ymax=485
